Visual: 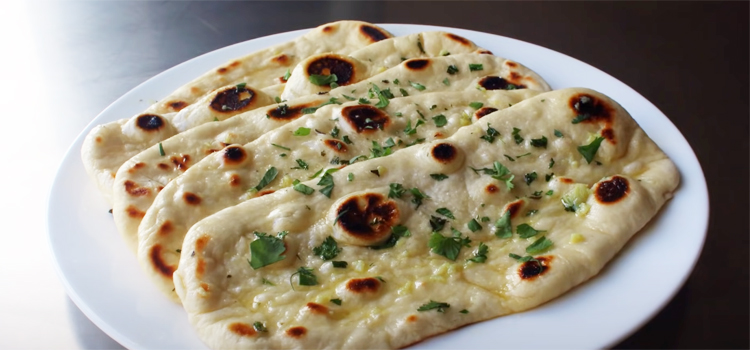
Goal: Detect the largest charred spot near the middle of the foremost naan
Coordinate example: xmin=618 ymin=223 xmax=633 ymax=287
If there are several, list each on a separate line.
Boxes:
xmin=336 ymin=193 xmax=399 ymax=241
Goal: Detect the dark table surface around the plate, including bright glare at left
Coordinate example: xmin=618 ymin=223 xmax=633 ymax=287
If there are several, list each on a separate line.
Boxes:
xmin=0 ymin=1 xmax=750 ymax=349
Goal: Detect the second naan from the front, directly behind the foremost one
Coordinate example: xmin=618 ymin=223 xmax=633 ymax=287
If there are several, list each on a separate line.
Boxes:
xmin=138 ymin=89 xmax=539 ymax=300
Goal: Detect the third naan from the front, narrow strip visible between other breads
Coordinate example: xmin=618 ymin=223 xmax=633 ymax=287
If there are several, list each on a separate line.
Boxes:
xmin=112 ymin=54 xmax=549 ymax=252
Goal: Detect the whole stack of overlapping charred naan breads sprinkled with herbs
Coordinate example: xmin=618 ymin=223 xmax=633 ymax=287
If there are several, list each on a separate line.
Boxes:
xmin=83 ymin=21 xmax=679 ymax=349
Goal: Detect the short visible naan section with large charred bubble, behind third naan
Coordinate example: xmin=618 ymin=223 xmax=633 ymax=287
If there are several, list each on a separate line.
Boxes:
xmin=281 ymin=32 xmax=490 ymax=100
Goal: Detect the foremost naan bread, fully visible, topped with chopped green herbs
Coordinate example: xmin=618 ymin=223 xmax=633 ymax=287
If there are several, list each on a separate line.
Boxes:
xmin=173 ymin=89 xmax=679 ymax=349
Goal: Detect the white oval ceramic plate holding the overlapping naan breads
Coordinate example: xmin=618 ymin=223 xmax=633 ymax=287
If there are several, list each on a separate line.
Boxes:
xmin=48 ymin=24 xmax=708 ymax=349
